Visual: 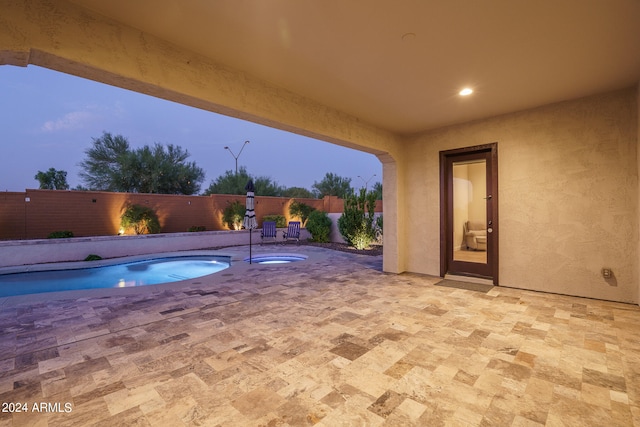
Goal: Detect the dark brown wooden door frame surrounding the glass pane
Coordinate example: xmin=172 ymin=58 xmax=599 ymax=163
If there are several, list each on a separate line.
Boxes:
xmin=440 ymin=142 xmax=500 ymax=285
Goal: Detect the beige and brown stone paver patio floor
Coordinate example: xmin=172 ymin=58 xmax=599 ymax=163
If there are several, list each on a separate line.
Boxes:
xmin=0 ymin=245 xmax=640 ymax=426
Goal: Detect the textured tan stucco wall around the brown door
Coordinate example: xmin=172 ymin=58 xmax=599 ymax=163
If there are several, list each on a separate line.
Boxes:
xmin=406 ymin=88 xmax=638 ymax=302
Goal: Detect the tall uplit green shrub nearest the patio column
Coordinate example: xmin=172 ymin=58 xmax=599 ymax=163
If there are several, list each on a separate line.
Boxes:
xmin=338 ymin=188 xmax=376 ymax=249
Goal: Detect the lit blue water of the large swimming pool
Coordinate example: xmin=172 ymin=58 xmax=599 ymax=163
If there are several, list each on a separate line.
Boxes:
xmin=0 ymin=256 xmax=230 ymax=297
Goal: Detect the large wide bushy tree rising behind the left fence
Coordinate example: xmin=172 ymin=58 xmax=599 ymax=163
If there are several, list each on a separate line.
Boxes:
xmin=80 ymin=132 xmax=204 ymax=195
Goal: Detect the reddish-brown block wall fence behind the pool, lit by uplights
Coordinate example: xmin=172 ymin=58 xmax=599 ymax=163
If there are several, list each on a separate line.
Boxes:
xmin=0 ymin=190 xmax=382 ymax=240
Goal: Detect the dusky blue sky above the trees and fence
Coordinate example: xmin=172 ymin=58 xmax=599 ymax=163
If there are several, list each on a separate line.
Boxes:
xmin=0 ymin=65 xmax=382 ymax=191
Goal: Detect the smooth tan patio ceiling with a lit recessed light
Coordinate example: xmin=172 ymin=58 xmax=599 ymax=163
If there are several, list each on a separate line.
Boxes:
xmin=67 ymin=0 xmax=640 ymax=134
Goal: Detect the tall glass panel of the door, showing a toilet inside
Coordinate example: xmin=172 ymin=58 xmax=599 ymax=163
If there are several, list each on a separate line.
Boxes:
xmin=452 ymin=159 xmax=487 ymax=264
